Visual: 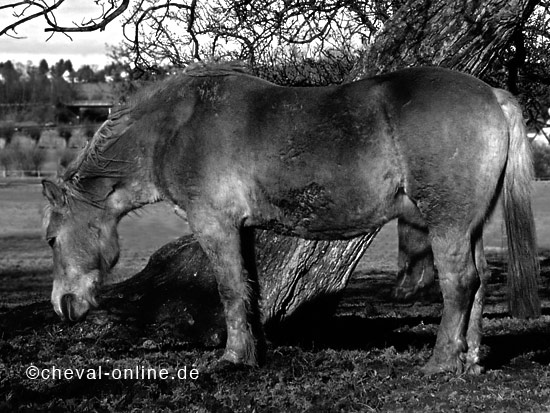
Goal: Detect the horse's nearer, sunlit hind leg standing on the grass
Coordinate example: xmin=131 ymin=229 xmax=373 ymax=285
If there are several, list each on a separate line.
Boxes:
xmin=423 ymin=229 xmax=480 ymax=374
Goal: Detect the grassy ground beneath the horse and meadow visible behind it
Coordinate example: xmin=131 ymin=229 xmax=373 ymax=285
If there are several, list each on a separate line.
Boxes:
xmin=0 ymin=181 xmax=550 ymax=412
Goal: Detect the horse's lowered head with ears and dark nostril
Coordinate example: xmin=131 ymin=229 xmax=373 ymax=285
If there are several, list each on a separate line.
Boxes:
xmin=42 ymin=180 xmax=120 ymax=321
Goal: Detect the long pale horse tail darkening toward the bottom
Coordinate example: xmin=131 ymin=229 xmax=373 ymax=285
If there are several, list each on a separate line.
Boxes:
xmin=494 ymin=89 xmax=541 ymax=318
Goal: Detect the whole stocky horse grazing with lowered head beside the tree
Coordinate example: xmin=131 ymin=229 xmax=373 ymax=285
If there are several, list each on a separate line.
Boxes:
xmin=43 ymin=66 xmax=538 ymax=373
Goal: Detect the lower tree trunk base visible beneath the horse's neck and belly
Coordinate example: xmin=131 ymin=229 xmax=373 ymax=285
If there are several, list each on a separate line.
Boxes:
xmin=117 ymin=230 xmax=384 ymax=345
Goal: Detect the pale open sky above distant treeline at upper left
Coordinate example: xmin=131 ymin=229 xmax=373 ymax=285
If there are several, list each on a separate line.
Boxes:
xmin=0 ymin=0 xmax=123 ymax=69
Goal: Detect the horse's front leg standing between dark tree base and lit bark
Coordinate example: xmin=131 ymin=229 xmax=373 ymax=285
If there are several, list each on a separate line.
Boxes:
xmin=188 ymin=213 xmax=265 ymax=366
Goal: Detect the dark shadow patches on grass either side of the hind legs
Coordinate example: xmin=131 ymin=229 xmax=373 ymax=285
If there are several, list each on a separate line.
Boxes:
xmin=274 ymin=309 xmax=550 ymax=370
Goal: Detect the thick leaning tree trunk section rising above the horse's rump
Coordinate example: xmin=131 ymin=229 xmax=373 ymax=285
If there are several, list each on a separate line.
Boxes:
xmin=350 ymin=0 xmax=538 ymax=79
